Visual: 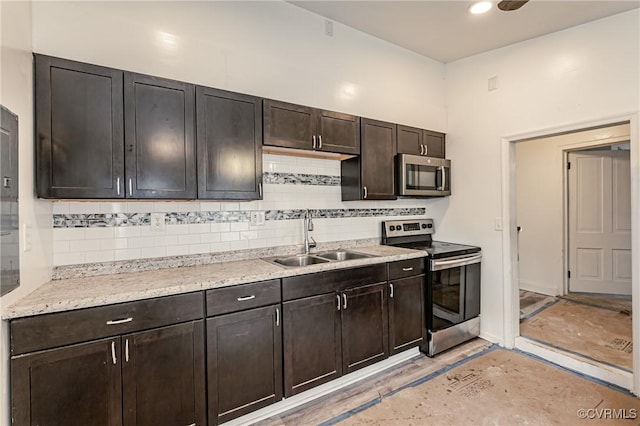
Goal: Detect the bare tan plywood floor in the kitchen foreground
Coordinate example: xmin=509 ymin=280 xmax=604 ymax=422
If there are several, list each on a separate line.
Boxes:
xmin=336 ymin=349 xmax=640 ymax=426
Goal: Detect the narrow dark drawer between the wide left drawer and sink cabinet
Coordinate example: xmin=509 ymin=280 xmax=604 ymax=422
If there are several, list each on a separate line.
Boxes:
xmin=207 ymin=280 xmax=281 ymax=317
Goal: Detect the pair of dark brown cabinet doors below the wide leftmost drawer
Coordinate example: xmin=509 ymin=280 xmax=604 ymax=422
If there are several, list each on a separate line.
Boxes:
xmin=11 ymin=320 xmax=206 ymax=426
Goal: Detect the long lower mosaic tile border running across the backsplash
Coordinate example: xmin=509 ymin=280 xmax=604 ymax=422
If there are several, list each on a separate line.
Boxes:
xmin=53 ymin=207 xmax=426 ymax=228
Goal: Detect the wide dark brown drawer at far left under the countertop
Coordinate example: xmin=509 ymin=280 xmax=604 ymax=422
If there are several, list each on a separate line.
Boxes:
xmin=11 ymin=292 xmax=204 ymax=355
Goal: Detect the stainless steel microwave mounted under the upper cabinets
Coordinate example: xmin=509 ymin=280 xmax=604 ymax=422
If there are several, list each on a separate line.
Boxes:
xmin=397 ymin=154 xmax=451 ymax=197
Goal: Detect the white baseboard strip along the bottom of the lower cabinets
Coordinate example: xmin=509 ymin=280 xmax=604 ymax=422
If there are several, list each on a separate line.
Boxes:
xmin=224 ymin=348 xmax=420 ymax=426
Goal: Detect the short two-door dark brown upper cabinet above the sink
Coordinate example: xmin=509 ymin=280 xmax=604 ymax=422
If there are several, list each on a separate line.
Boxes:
xmin=263 ymin=100 xmax=360 ymax=155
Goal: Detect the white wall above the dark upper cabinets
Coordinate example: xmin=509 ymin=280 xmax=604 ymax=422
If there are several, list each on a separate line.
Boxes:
xmin=33 ymin=2 xmax=446 ymax=131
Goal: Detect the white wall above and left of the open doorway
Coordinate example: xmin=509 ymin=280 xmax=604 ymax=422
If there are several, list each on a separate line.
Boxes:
xmin=438 ymin=10 xmax=640 ymax=341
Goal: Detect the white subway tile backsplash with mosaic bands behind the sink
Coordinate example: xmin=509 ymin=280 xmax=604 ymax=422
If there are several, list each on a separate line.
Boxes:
xmin=53 ymin=154 xmax=427 ymax=266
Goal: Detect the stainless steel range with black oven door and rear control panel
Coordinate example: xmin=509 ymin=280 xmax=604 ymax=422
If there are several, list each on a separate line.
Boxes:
xmin=382 ymin=219 xmax=482 ymax=356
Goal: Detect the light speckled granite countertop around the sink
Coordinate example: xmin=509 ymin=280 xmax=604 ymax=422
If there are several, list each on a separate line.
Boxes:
xmin=2 ymin=245 xmax=426 ymax=320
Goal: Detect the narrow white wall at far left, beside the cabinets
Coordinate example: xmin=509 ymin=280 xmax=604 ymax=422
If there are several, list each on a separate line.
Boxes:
xmin=0 ymin=1 xmax=52 ymax=425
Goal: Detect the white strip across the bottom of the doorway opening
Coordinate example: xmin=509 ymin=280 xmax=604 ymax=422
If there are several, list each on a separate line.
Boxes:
xmin=516 ymin=337 xmax=633 ymax=392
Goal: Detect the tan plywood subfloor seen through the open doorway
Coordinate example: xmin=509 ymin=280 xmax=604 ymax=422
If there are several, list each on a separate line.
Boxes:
xmin=520 ymin=300 xmax=633 ymax=371
